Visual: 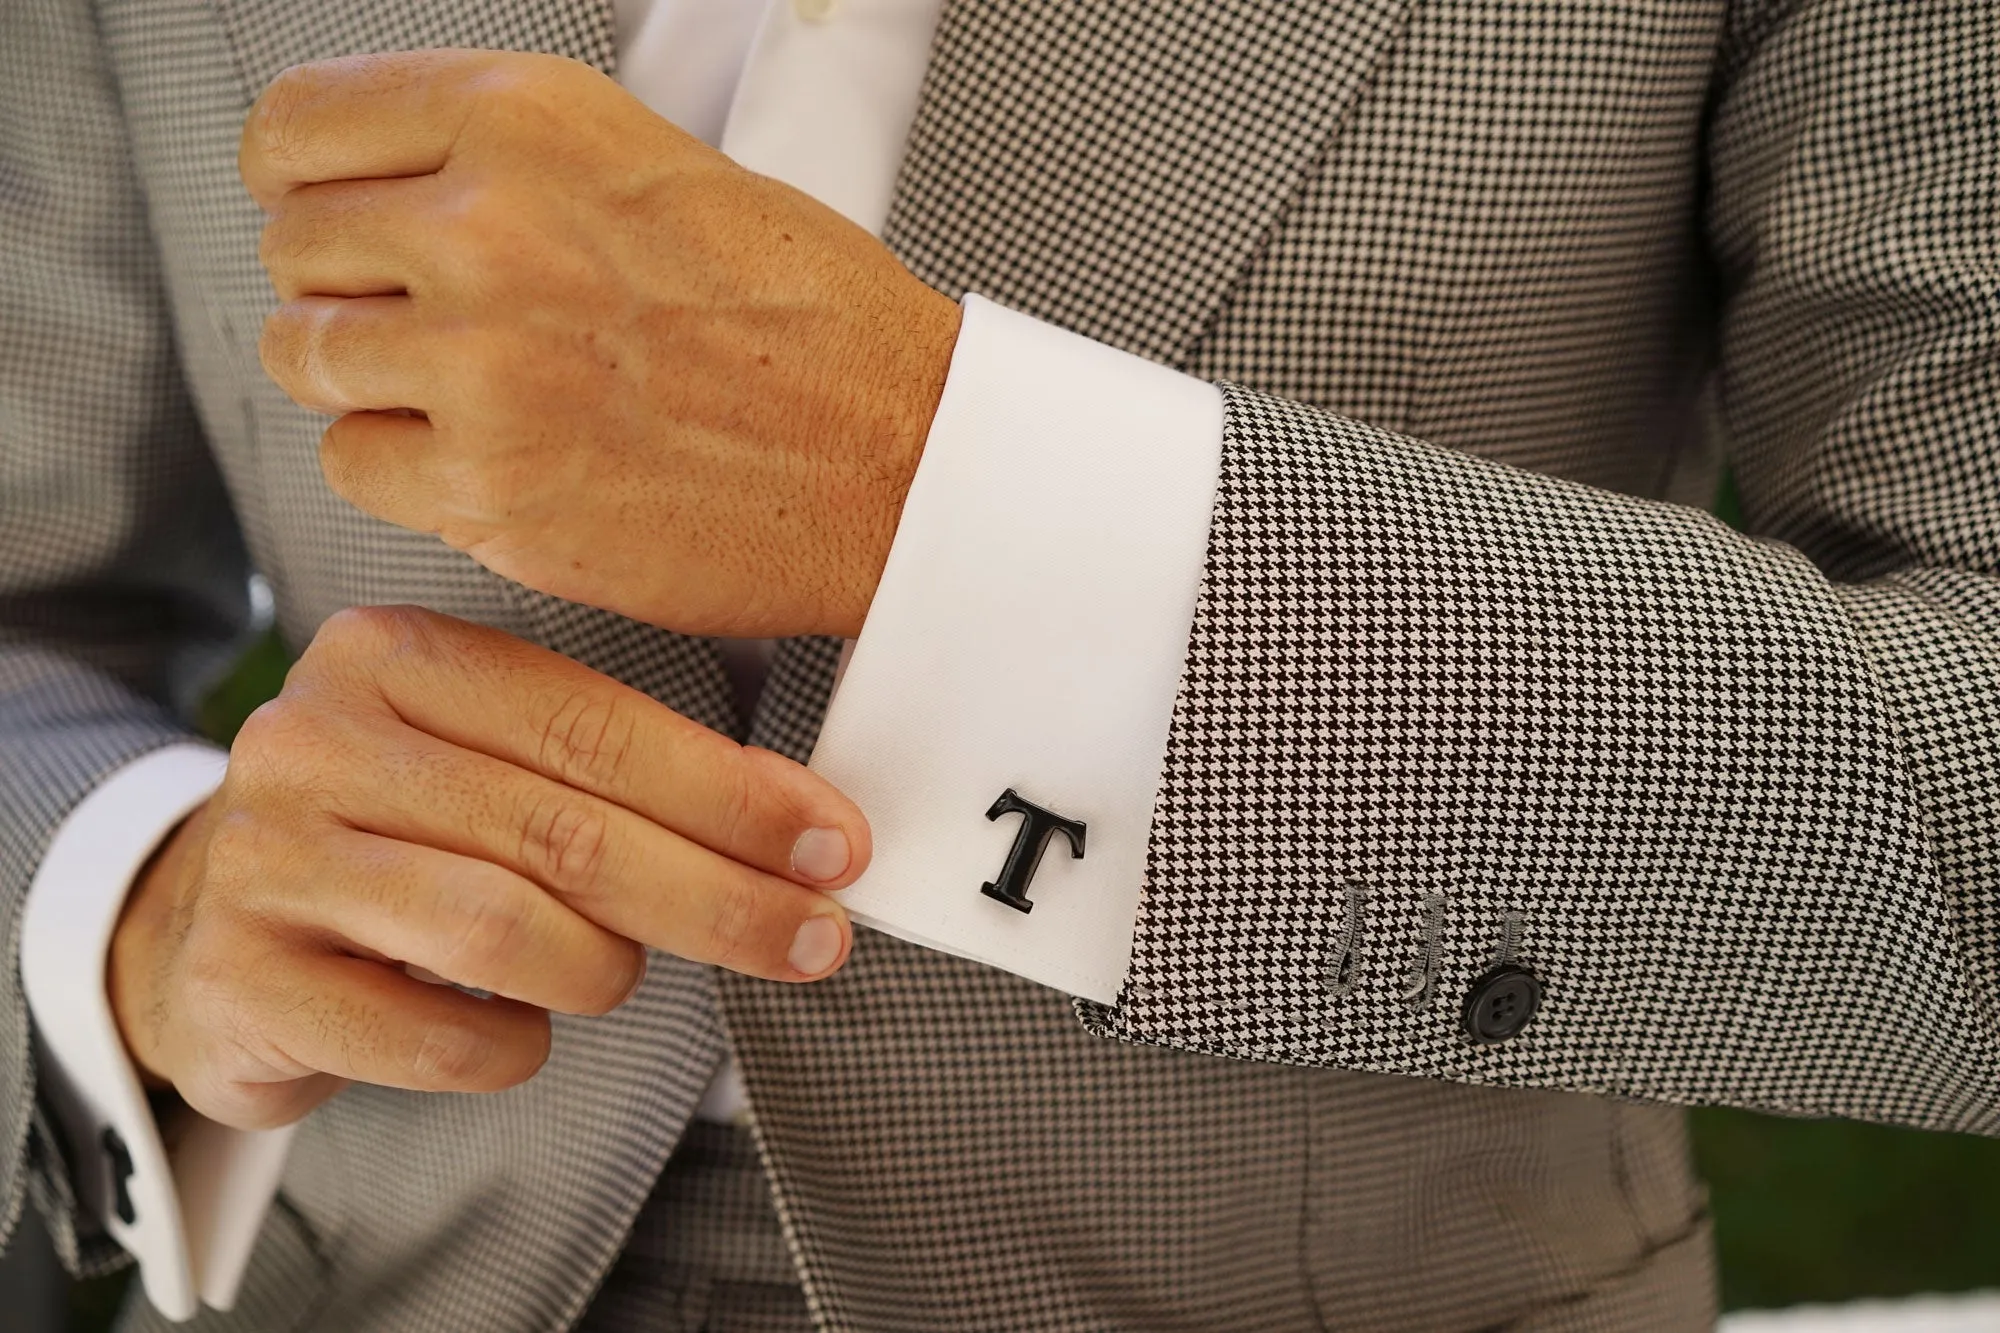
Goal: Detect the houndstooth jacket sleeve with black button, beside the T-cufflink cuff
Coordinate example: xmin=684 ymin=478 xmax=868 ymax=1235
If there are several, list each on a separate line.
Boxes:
xmin=1082 ymin=0 xmax=2000 ymax=1133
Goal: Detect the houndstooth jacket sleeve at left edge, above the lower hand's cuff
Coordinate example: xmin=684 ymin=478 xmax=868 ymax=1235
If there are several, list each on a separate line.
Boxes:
xmin=0 ymin=4 xmax=248 ymax=1271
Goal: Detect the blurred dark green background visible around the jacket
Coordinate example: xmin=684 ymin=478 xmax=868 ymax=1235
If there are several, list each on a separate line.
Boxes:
xmin=43 ymin=472 xmax=2000 ymax=1312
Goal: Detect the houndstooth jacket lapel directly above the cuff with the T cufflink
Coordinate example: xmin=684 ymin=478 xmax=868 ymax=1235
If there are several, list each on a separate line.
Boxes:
xmin=886 ymin=0 xmax=1410 ymax=364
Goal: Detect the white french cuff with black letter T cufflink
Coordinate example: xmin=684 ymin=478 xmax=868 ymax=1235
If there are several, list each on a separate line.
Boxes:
xmin=812 ymin=296 xmax=1222 ymax=1005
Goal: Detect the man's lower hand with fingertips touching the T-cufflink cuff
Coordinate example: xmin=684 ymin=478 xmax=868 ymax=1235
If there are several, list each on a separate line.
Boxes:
xmin=110 ymin=608 xmax=870 ymax=1127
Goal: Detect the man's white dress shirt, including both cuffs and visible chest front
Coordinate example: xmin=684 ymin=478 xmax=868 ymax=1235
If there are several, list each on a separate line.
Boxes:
xmin=22 ymin=0 xmax=1222 ymax=1319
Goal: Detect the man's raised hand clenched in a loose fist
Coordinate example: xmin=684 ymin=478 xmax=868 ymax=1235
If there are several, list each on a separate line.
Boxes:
xmin=240 ymin=50 xmax=958 ymax=636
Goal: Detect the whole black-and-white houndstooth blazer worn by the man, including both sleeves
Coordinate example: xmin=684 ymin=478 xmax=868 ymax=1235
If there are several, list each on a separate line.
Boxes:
xmin=0 ymin=0 xmax=2000 ymax=1329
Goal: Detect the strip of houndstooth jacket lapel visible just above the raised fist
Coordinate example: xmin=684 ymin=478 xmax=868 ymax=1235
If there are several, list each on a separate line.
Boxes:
xmin=216 ymin=0 xmax=612 ymax=98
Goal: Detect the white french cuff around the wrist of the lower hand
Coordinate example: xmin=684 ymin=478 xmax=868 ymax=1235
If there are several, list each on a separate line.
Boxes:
xmin=20 ymin=745 xmax=292 ymax=1319
